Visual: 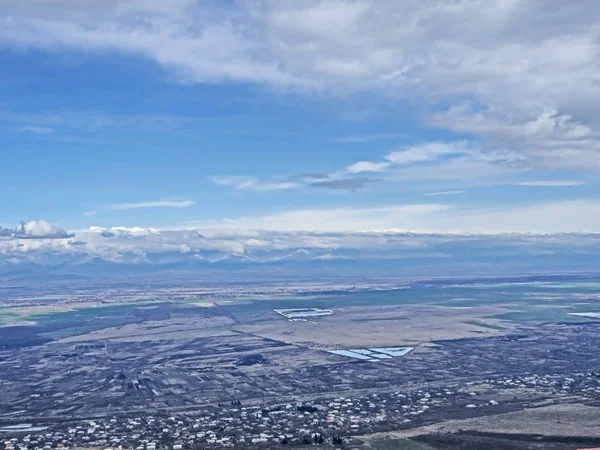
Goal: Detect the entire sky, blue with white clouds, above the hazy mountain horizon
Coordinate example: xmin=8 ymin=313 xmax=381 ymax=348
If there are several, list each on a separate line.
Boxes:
xmin=0 ymin=0 xmax=600 ymax=268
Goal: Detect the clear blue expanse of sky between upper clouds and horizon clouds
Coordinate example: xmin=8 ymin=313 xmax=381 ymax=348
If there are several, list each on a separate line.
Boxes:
xmin=0 ymin=49 xmax=440 ymax=227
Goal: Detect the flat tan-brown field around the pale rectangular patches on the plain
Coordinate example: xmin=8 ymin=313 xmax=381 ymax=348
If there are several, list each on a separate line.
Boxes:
xmin=37 ymin=302 xmax=515 ymax=351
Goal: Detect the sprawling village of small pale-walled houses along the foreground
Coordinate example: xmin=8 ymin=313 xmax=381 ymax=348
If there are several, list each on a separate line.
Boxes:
xmin=5 ymin=373 xmax=600 ymax=450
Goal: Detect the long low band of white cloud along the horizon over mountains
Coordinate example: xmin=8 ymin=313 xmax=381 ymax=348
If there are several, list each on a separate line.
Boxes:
xmin=0 ymin=201 xmax=600 ymax=271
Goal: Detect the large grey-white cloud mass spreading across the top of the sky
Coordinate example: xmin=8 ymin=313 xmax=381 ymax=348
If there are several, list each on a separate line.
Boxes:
xmin=0 ymin=0 xmax=600 ymax=171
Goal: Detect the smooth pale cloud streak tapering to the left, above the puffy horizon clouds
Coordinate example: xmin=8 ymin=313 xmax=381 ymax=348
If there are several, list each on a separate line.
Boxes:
xmin=190 ymin=200 xmax=600 ymax=234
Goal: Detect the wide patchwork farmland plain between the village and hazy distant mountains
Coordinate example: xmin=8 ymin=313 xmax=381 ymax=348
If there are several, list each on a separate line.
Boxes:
xmin=0 ymin=274 xmax=600 ymax=449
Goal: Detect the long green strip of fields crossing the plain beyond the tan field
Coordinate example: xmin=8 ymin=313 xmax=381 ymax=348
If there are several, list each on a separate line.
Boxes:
xmin=0 ymin=280 xmax=600 ymax=338
